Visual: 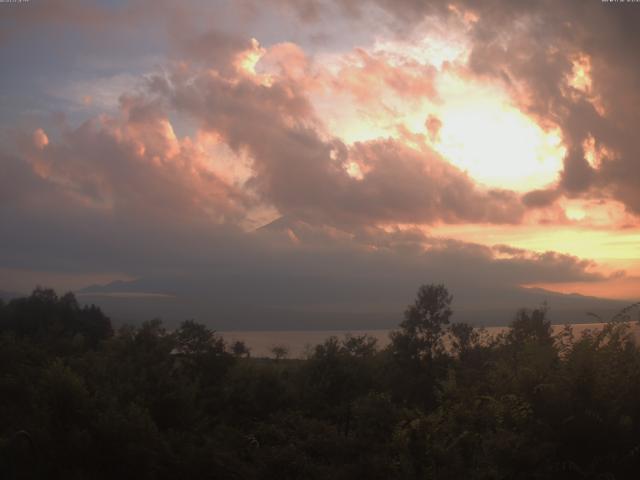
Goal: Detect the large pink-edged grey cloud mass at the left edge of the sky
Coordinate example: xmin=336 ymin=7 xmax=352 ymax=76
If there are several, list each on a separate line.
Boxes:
xmin=0 ymin=97 xmax=255 ymax=274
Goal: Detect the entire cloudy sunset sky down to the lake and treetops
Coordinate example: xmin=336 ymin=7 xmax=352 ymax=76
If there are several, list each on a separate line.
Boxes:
xmin=0 ymin=0 xmax=640 ymax=329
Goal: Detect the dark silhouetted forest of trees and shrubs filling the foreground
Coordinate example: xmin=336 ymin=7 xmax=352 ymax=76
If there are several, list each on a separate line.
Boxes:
xmin=0 ymin=284 xmax=640 ymax=480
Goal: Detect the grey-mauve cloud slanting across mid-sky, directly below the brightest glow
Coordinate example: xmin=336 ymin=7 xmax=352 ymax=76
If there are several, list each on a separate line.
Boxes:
xmin=155 ymin=57 xmax=524 ymax=225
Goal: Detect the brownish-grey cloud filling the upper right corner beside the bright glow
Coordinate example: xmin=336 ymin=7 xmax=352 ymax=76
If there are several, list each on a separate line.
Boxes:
xmin=276 ymin=0 xmax=640 ymax=215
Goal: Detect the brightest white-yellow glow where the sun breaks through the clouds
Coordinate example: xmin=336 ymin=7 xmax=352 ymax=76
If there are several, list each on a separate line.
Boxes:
xmin=272 ymin=37 xmax=566 ymax=192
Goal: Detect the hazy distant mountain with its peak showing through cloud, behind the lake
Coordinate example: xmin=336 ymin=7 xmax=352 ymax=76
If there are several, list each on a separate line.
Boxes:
xmin=72 ymin=217 xmax=626 ymax=330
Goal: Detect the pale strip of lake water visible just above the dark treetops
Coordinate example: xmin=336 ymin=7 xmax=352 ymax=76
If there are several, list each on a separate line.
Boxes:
xmin=217 ymin=322 xmax=640 ymax=358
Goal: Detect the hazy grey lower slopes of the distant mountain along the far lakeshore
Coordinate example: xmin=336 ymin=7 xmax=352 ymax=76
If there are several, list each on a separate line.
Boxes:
xmin=77 ymin=275 xmax=627 ymax=330
